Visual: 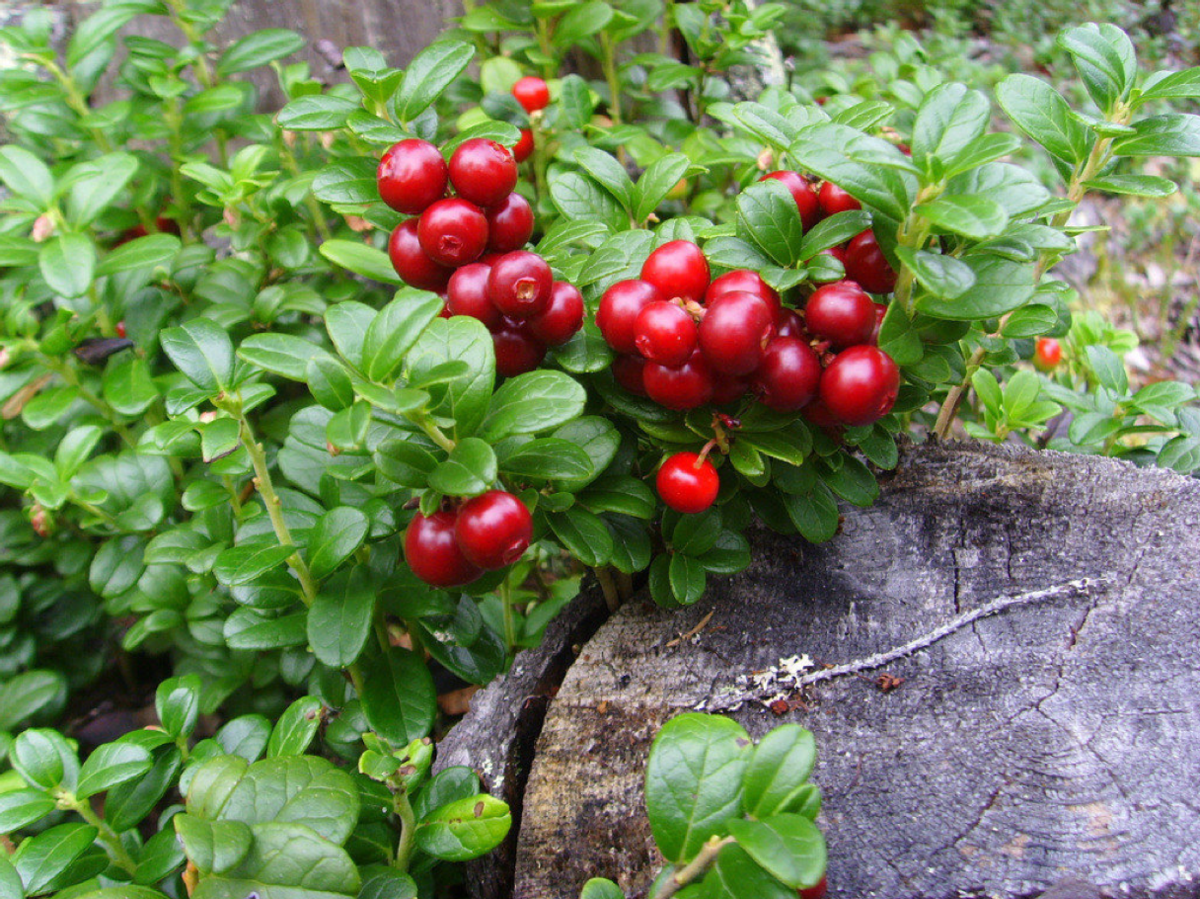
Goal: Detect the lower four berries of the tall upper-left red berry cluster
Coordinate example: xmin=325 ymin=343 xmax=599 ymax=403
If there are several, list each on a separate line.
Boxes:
xmin=443 ymin=250 xmax=584 ymax=378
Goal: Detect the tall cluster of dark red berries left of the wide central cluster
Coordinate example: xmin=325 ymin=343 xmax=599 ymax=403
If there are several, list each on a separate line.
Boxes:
xmin=378 ymin=138 xmax=583 ymax=377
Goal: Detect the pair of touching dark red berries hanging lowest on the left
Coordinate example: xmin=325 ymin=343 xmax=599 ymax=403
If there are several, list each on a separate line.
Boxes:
xmin=404 ymin=490 xmax=533 ymax=588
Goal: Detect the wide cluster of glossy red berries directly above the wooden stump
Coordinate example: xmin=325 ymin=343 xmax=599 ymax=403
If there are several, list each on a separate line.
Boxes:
xmin=596 ymin=240 xmax=900 ymax=425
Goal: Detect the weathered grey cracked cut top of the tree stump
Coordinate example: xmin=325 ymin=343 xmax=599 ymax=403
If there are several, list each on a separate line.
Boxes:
xmin=496 ymin=444 xmax=1200 ymax=899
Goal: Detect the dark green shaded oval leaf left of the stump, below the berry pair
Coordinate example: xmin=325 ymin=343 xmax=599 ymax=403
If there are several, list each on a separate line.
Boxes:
xmin=360 ymin=648 xmax=437 ymax=747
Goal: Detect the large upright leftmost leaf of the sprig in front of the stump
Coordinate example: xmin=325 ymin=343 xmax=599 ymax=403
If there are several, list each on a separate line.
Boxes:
xmin=646 ymin=712 xmax=754 ymax=864
